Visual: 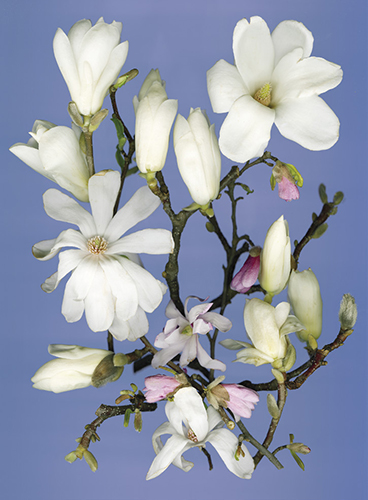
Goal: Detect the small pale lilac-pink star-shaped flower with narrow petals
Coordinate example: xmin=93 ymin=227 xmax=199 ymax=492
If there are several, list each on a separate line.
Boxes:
xmin=152 ymin=296 xmax=232 ymax=371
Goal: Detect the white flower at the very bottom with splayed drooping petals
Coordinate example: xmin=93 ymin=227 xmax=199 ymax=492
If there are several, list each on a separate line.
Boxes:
xmin=146 ymin=387 xmax=254 ymax=480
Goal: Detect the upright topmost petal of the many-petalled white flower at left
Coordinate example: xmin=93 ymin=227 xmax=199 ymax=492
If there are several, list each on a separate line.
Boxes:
xmin=88 ymin=170 xmax=120 ymax=236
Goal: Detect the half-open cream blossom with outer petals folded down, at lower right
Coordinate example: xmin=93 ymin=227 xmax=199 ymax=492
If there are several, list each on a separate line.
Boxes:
xmin=220 ymin=298 xmax=304 ymax=366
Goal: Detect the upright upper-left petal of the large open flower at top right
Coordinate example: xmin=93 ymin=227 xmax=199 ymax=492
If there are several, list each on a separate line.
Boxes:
xmin=233 ymin=16 xmax=274 ymax=95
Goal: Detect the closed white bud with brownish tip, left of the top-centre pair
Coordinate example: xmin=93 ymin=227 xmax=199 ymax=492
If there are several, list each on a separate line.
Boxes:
xmin=133 ymin=69 xmax=178 ymax=174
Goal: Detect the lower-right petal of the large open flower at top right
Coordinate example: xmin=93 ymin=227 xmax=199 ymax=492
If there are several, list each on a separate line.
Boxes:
xmin=275 ymin=96 xmax=340 ymax=151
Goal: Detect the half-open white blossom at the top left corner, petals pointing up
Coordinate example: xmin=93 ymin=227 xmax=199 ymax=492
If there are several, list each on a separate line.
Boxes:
xmin=54 ymin=17 xmax=128 ymax=116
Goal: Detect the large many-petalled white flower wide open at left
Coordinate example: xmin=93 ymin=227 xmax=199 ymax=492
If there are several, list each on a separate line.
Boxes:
xmin=33 ymin=170 xmax=173 ymax=340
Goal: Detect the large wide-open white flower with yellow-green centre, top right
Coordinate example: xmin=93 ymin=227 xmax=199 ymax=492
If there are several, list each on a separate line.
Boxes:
xmin=207 ymin=17 xmax=342 ymax=162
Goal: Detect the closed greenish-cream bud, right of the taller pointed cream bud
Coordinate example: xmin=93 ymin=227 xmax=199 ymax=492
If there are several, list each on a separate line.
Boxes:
xmin=288 ymin=268 xmax=322 ymax=341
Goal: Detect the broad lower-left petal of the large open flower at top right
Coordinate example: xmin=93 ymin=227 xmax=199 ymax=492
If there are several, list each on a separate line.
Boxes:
xmin=219 ymin=96 xmax=275 ymax=163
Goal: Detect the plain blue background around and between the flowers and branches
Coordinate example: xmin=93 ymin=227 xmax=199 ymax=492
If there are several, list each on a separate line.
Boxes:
xmin=0 ymin=0 xmax=367 ymax=500
